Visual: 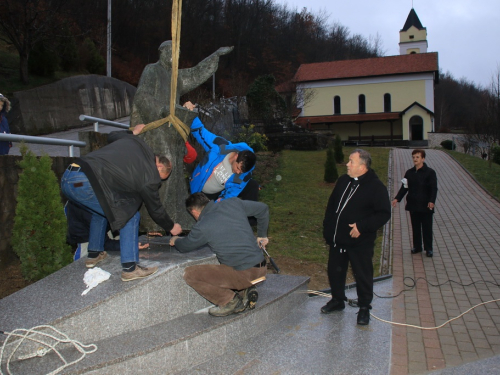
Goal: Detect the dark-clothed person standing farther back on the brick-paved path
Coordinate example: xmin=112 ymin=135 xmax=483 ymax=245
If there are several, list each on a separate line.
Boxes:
xmin=392 ymin=149 xmax=437 ymax=258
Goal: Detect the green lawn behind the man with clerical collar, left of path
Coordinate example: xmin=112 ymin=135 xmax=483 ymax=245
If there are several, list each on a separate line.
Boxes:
xmin=256 ymin=148 xmax=390 ymax=272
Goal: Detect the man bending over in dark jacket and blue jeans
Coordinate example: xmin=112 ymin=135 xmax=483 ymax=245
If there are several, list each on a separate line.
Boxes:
xmin=61 ymin=124 xmax=182 ymax=281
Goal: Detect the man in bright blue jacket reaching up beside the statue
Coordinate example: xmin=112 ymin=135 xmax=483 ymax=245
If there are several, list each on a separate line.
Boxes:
xmin=184 ymin=102 xmax=259 ymax=202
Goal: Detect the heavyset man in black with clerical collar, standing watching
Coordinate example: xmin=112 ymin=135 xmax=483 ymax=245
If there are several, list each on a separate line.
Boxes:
xmin=321 ymin=149 xmax=391 ymax=325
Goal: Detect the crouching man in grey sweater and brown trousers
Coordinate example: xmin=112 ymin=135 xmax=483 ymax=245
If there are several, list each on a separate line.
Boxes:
xmin=170 ymin=193 xmax=269 ymax=316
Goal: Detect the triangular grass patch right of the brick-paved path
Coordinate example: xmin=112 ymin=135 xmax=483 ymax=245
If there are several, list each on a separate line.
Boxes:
xmin=444 ymin=150 xmax=500 ymax=200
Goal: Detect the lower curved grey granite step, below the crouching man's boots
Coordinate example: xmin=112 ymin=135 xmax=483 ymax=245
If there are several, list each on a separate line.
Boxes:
xmin=1 ymin=274 xmax=309 ymax=375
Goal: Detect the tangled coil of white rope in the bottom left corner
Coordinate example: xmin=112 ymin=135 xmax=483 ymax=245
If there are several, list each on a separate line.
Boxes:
xmin=0 ymin=325 xmax=97 ymax=375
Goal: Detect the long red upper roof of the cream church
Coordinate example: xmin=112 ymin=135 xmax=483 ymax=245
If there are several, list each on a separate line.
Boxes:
xmin=294 ymin=52 xmax=439 ymax=83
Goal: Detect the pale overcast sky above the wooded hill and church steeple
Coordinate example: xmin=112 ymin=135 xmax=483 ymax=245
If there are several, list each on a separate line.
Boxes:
xmin=275 ymin=0 xmax=500 ymax=87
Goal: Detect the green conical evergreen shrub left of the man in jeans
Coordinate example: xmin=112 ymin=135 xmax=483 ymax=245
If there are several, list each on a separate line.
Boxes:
xmin=12 ymin=145 xmax=72 ymax=281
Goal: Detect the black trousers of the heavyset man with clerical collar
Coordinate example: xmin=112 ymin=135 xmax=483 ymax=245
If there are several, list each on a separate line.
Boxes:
xmin=328 ymin=245 xmax=373 ymax=307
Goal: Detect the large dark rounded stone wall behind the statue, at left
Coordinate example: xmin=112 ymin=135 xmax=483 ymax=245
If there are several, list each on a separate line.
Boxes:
xmin=8 ymin=75 xmax=136 ymax=135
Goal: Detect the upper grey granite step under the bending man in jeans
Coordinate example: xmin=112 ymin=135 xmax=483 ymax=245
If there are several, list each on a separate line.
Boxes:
xmin=0 ymin=238 xmax=217 ymax=343
